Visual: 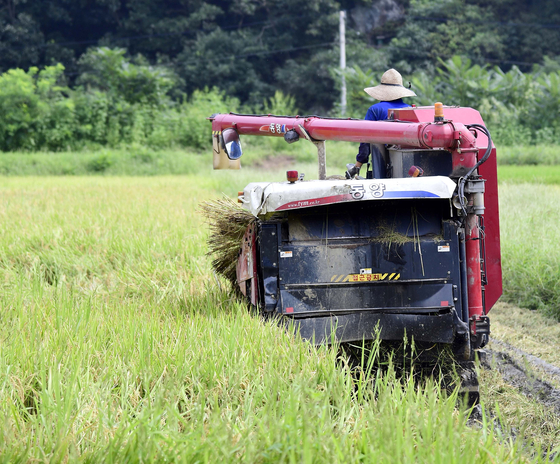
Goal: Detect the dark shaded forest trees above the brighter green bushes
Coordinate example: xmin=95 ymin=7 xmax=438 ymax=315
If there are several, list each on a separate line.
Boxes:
xmin=0 ymin=0 xmax=560 ymax=112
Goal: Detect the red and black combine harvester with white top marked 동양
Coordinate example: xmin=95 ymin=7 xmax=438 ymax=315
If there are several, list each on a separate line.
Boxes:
xmin=210 ymin=104 xmax=502 ymax=374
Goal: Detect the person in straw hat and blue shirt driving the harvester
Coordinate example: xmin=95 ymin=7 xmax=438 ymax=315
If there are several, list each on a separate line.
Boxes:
xmin=346 ymin=68 xmax=416 ymax=179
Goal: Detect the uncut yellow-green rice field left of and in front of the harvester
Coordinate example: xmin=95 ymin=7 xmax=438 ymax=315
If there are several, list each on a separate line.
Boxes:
xmin=0 ymin=176 xmax=540 ymax=463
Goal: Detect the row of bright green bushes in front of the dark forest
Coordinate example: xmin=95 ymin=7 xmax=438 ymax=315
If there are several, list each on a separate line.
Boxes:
xmin=0 ymin=52 xmax=560 ymax=151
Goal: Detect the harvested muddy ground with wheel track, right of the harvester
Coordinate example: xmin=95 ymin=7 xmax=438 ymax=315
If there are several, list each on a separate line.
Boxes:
xmin=479 ymin=303 xmax=560 ymax=456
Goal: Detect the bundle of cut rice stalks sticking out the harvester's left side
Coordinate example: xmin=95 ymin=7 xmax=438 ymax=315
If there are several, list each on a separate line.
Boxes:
xmin=200 ymin=196 xmax=257 ymax=289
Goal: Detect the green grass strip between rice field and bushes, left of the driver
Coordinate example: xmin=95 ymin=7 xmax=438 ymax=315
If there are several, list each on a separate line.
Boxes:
xmin=0 ymin=137 xmax=357 ymax=179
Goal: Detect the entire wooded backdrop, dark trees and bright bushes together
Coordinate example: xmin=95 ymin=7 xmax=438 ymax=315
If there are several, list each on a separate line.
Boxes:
xmin=0 ymin=0 xmax=560 ymax=151
